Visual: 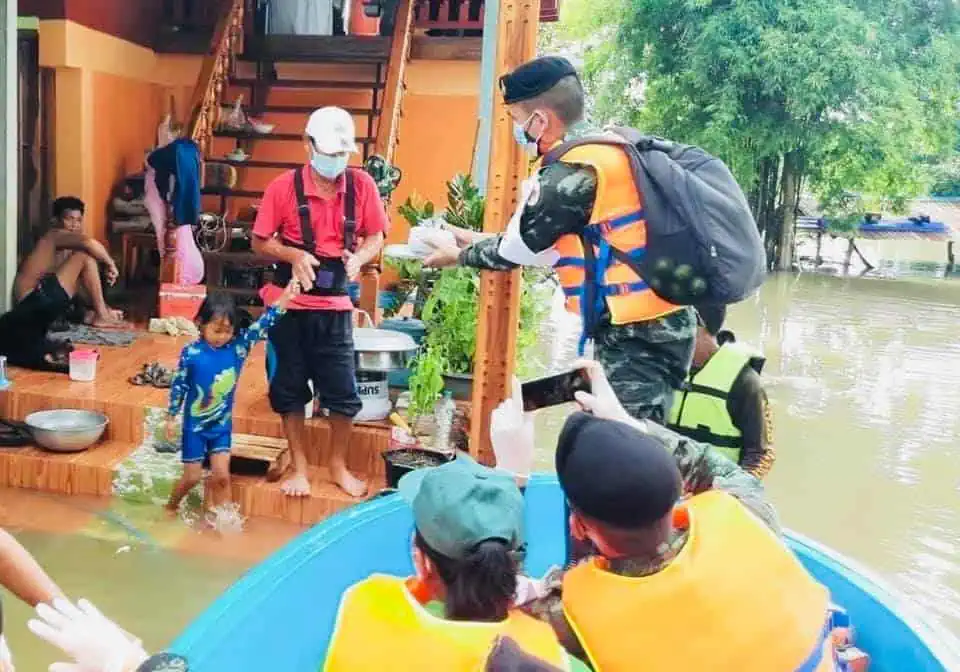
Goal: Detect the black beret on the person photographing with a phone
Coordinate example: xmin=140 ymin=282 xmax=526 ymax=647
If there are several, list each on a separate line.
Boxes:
xmin=555 ymin=413 xmax=681 ymax=529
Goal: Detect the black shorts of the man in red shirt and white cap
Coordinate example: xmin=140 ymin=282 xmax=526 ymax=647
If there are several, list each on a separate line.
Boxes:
xmin=269 ymin=310 xmax=362 ymax=418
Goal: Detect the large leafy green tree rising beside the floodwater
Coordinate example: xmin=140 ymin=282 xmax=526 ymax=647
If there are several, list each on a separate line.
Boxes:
xmin=561 ymin=0 xmax=960 ymax=268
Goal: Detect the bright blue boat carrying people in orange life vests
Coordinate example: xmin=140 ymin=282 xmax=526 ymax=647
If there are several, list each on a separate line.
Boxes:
xmin=171 ymin=476 xmax=960 ymax=672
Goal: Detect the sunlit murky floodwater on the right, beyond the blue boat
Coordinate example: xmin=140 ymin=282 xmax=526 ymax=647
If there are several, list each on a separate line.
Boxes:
xmin=538 ymin=272 xmax=960 ymax=633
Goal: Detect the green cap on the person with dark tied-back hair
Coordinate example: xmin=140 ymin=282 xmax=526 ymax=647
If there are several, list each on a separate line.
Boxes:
xmin=398 ymin=453 xmax=523 ymax=560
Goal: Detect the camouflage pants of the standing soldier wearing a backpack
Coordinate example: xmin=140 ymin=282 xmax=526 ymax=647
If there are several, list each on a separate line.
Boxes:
xmin=594 ymin=308 xmax=697 ymax=424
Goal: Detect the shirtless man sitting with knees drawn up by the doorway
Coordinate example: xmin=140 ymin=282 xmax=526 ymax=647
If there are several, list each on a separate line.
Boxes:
xmin=34 ymin=196 xmax=123 ymax=327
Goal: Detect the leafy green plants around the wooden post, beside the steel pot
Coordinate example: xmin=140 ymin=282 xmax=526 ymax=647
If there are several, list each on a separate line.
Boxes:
xmin=390 ymin=175 xmax=550 ymax=418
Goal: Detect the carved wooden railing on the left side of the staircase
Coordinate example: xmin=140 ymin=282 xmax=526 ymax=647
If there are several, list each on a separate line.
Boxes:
xmin=188 ymin=0 xmax=246 ymax=155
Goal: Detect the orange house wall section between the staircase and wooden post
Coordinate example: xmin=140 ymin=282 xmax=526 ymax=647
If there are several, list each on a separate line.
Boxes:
xmin=389 ymin=59 xmax=480 ymax=243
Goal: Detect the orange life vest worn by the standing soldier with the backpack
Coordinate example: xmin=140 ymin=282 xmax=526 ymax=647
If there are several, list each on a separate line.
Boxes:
xmin=554 ymin=145 xmax=680 ymax=333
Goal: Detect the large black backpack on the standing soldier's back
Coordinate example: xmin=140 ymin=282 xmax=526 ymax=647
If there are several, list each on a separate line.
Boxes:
xmin=543 ymin=128 xmax=767 ymax=305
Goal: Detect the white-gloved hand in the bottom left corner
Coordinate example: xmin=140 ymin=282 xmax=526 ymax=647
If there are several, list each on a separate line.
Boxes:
xmin=27 ymin=598 xmax=147 ymax=672
